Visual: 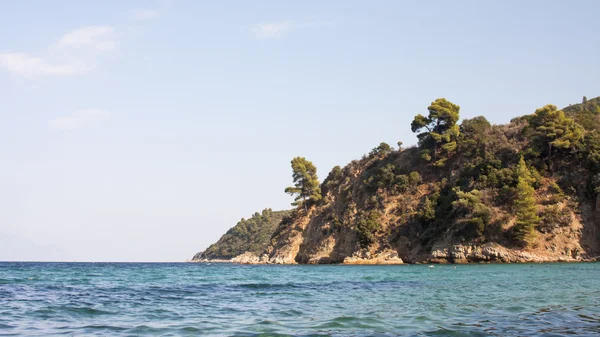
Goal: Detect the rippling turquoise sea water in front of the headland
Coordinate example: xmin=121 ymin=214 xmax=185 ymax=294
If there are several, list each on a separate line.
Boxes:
xmin=0 ymin=263 xmax=600 ymax=336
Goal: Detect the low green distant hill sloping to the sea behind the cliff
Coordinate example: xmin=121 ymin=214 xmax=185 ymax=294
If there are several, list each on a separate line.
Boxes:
xmin=193 ymin=208 xmax=291 ymax=261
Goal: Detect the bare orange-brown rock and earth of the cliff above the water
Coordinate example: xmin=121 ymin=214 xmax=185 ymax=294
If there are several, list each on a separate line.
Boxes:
xmin=262 ymin=149 xmax=600 ymax=264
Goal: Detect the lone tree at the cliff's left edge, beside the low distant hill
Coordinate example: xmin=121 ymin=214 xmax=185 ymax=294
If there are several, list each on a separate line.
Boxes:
xmin=285 ymin=157 xmax=322 ymax=214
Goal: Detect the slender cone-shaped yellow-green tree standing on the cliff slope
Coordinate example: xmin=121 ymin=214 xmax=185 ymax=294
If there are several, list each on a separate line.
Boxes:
xmin=513 ymin=157 xmax=540 ymax=243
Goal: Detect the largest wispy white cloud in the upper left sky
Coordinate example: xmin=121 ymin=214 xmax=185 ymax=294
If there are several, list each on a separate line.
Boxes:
xmin=0 ymin=26 xmax=117 ymax=77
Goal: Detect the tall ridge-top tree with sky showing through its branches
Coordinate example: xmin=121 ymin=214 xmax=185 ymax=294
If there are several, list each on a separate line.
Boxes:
xmin=411 ymin=98 xmax=460 ymax=166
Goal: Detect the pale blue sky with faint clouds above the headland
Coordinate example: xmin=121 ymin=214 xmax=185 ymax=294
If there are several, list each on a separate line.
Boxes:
xmin=0 ymin=0 xmax=600 ymax=261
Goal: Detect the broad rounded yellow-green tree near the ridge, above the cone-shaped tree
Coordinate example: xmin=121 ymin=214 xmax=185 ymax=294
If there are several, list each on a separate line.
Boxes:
xmin=529 ymin=104 xmax=584 ymax=172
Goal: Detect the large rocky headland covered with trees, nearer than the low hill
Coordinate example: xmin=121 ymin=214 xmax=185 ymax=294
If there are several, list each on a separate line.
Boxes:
xmin=195 ymin=98 xmax=600 ymax=264
